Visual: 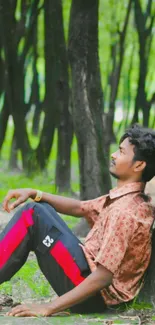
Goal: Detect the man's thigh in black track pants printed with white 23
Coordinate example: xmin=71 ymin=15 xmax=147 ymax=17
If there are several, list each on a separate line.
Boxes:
xmin=31 ymin=203 xmax=90 ymax=296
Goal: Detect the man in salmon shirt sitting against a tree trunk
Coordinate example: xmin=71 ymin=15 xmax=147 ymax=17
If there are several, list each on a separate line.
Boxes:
xmin=0 ymin=125 xmax=155 ymax=316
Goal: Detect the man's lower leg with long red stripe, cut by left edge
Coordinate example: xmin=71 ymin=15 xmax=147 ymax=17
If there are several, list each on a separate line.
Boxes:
xmin=0 ymin=204 xmax=34 ymax=284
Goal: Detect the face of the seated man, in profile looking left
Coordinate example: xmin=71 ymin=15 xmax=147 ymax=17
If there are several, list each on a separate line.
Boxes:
xmin=109 ymin=138 xmax=134 ymax=180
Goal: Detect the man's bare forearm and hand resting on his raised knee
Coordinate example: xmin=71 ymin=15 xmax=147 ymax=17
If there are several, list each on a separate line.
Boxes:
xmin=3 ymin=188 xmax=83 ymax=217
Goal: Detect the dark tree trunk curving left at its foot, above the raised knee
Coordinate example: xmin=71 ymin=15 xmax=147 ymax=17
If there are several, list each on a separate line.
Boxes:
xmin=37 ymin=0 xmax=59 ymax=169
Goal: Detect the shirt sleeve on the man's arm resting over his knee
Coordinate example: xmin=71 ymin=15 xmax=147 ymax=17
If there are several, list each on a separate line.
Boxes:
xmin=81 ymin=195 xmax=106 ymax=227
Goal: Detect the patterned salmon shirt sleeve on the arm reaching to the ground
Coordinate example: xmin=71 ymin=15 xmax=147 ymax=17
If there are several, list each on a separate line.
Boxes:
xmin=95 ymin=211 xmax=136 ymax=274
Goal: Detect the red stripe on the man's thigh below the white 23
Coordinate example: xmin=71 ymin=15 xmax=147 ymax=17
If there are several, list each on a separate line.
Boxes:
xmin=50 ymin=241 xmax=85 ymax=286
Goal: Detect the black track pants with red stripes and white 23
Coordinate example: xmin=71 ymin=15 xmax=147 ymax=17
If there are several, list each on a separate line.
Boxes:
xmin=0 ymin=202 xmax=105 ymax=313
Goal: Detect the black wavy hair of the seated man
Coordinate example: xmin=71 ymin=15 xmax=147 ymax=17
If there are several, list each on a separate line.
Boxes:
xmin=120 ymin=124 xmax=155 ymax=182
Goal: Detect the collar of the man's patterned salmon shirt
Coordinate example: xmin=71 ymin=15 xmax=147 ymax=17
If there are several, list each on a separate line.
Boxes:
xmin=109 ymin=182 xmax=145 ymax=199
